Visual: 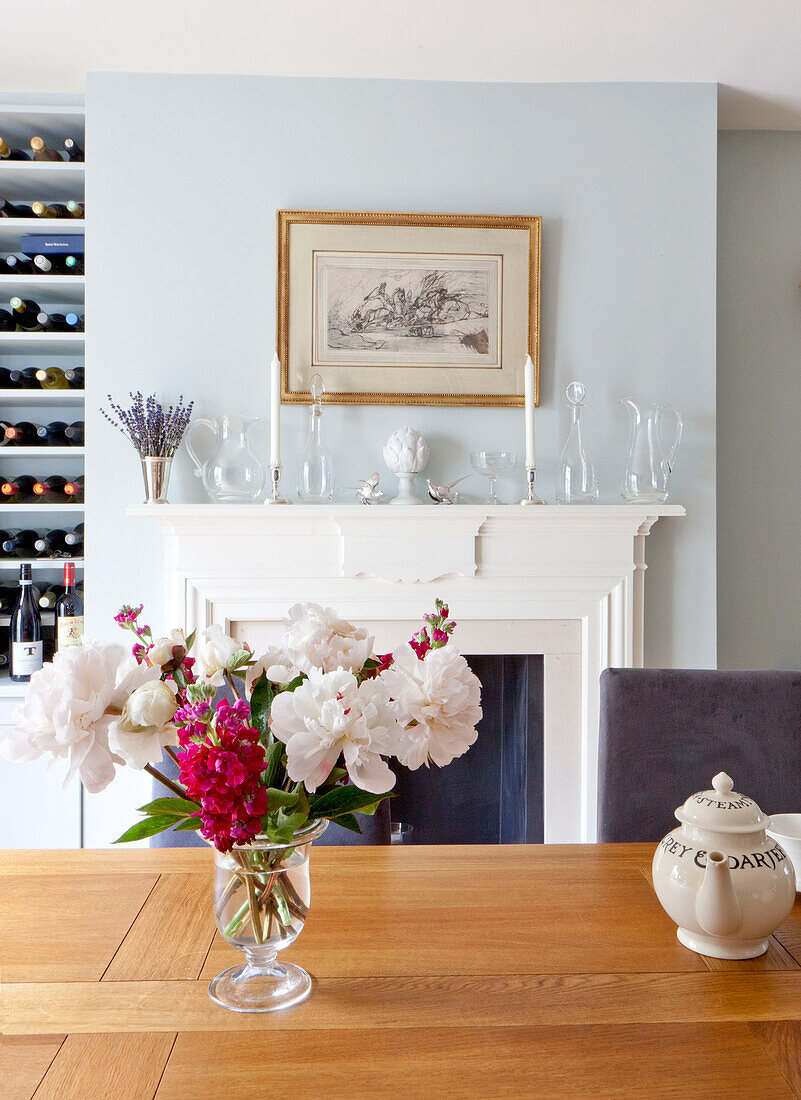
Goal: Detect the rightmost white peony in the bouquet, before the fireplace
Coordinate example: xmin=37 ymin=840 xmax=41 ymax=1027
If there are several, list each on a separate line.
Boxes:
xmin=378 ymin=644 xmax=482 ymax=770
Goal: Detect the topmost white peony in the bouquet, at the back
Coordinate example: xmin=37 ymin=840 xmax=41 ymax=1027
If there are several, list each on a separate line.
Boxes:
xmin=283 ymin=604 xmax=374 ymax=675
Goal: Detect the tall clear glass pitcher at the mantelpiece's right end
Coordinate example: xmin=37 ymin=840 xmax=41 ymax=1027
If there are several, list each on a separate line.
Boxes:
xmin=621 ymin=397 xmax=684 ymax=504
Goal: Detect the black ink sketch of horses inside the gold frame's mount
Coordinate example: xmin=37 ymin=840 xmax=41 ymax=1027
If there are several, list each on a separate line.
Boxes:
xmin=312 ymin=252 xmax=502 ymax=367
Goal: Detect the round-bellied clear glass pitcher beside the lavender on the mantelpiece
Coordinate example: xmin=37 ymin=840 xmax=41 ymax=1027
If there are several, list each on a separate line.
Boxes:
xmin=186 ymin=413 xmax=264 ymax=504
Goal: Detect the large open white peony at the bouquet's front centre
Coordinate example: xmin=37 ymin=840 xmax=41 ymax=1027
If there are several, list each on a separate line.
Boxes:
xmin=270 ymin=668 xmax=399 ymax=794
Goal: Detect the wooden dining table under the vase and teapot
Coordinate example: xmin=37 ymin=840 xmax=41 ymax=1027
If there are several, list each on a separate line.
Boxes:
xmin=0 ymin=845 xmax=801 ymax=1100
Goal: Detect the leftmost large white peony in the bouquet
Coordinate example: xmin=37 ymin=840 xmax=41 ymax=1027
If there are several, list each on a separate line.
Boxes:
xmin=0 ymin=641 xmax=158 ymax=794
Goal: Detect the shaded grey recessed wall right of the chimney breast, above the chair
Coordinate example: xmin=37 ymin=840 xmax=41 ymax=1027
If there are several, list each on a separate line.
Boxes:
xmin=717 ymin=132 xmax=801 ymax=669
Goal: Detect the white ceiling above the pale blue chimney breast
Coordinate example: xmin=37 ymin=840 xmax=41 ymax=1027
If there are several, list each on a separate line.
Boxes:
xmin=6 ymin=0 xmax=801 ymax=130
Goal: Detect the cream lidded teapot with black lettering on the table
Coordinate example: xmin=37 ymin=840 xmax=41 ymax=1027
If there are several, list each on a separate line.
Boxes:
xmin=652 ymin=771 xmax=795 ymax=959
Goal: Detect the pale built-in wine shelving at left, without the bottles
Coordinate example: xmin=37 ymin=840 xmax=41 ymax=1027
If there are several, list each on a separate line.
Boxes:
xmin=0 ymin=96 xmax=84 ymax=695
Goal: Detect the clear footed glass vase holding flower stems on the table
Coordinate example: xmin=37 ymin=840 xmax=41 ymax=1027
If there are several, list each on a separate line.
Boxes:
xmin=209 ymin=821 xmax=328 ymax=1012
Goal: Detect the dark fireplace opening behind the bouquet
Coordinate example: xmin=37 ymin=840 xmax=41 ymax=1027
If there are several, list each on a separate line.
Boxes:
xmin=389 ymin=655 xmax=545 ymax=844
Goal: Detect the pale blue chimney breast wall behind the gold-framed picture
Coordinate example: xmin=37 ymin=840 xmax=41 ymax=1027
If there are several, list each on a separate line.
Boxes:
xmin=87 ymin=74 xmax=716 ymax=843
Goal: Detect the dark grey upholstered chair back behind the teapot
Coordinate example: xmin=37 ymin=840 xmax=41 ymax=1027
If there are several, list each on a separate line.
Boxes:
xmin=599 ymin=669 xmax=801 ymax=842
